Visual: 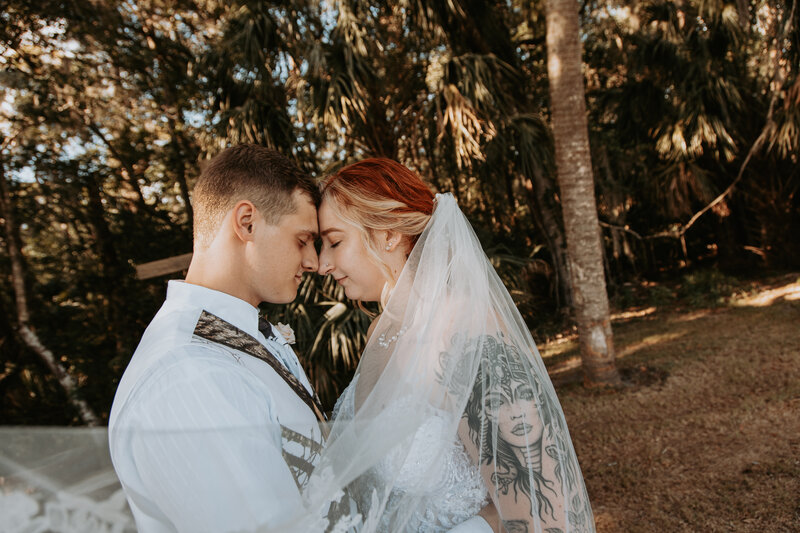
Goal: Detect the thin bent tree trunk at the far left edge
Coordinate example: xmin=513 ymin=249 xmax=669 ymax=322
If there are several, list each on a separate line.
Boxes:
xmin=0 ymin=160 xmax=100 ymax=426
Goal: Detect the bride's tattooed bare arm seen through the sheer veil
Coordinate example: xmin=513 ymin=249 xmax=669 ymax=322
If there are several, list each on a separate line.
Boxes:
xmin=459 ymin=337 xmax=584 ymax=533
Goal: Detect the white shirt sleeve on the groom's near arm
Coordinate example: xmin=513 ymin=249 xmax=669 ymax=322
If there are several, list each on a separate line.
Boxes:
xmin=123 ymin=350 xmax=301 ymax=532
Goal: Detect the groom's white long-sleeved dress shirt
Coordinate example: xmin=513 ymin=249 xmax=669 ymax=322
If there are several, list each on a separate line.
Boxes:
xmin=109 ymin=281 xmax=322 ymax=533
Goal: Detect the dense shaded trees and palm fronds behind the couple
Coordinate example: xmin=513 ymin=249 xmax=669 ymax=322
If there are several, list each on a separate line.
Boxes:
xmin=0 ymin=0 xmax=800 ymax=425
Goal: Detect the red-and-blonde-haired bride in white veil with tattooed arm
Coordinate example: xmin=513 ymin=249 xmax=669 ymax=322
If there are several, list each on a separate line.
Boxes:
xmin=306 ymin=159 xmax=594 ymax=533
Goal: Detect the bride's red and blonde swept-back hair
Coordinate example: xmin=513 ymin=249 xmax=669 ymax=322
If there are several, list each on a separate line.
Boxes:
xmin=321 ymin=158 xmax=433 ymax=305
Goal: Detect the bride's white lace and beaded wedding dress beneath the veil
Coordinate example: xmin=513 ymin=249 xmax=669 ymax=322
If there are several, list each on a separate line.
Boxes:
xmin=333 ymin=376 xmax=489 ymax=533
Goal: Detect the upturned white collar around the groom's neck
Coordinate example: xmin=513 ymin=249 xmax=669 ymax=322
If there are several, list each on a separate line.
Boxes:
xmin=166 ymin=280 xmax=258 ymax=338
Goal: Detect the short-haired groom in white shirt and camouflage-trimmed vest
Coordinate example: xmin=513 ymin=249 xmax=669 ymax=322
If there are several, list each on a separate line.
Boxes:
xmin=109 ymin=145 xmax=325 ymax=533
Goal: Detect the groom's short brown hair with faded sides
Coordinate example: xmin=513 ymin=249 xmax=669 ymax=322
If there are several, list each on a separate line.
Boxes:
xmin=192 ymin=144 xmax=319 ymax=248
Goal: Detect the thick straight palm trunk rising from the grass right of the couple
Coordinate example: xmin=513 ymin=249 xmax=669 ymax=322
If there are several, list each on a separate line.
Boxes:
xmin=546 ymin=0 xmax=620 ymax=386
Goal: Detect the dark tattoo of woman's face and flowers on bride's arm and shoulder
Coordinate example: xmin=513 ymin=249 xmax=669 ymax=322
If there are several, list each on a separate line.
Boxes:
xmin=440 ymin=334 xmax=593 ymax=533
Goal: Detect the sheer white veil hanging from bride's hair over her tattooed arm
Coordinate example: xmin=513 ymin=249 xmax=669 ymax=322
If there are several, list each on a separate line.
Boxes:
xmin=296 ymin=194 xmax=594 ymax=533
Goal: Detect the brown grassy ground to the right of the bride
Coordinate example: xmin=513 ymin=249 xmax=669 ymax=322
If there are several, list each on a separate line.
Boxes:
xmin=542 ymin=277 xmax=800 ymax=533
